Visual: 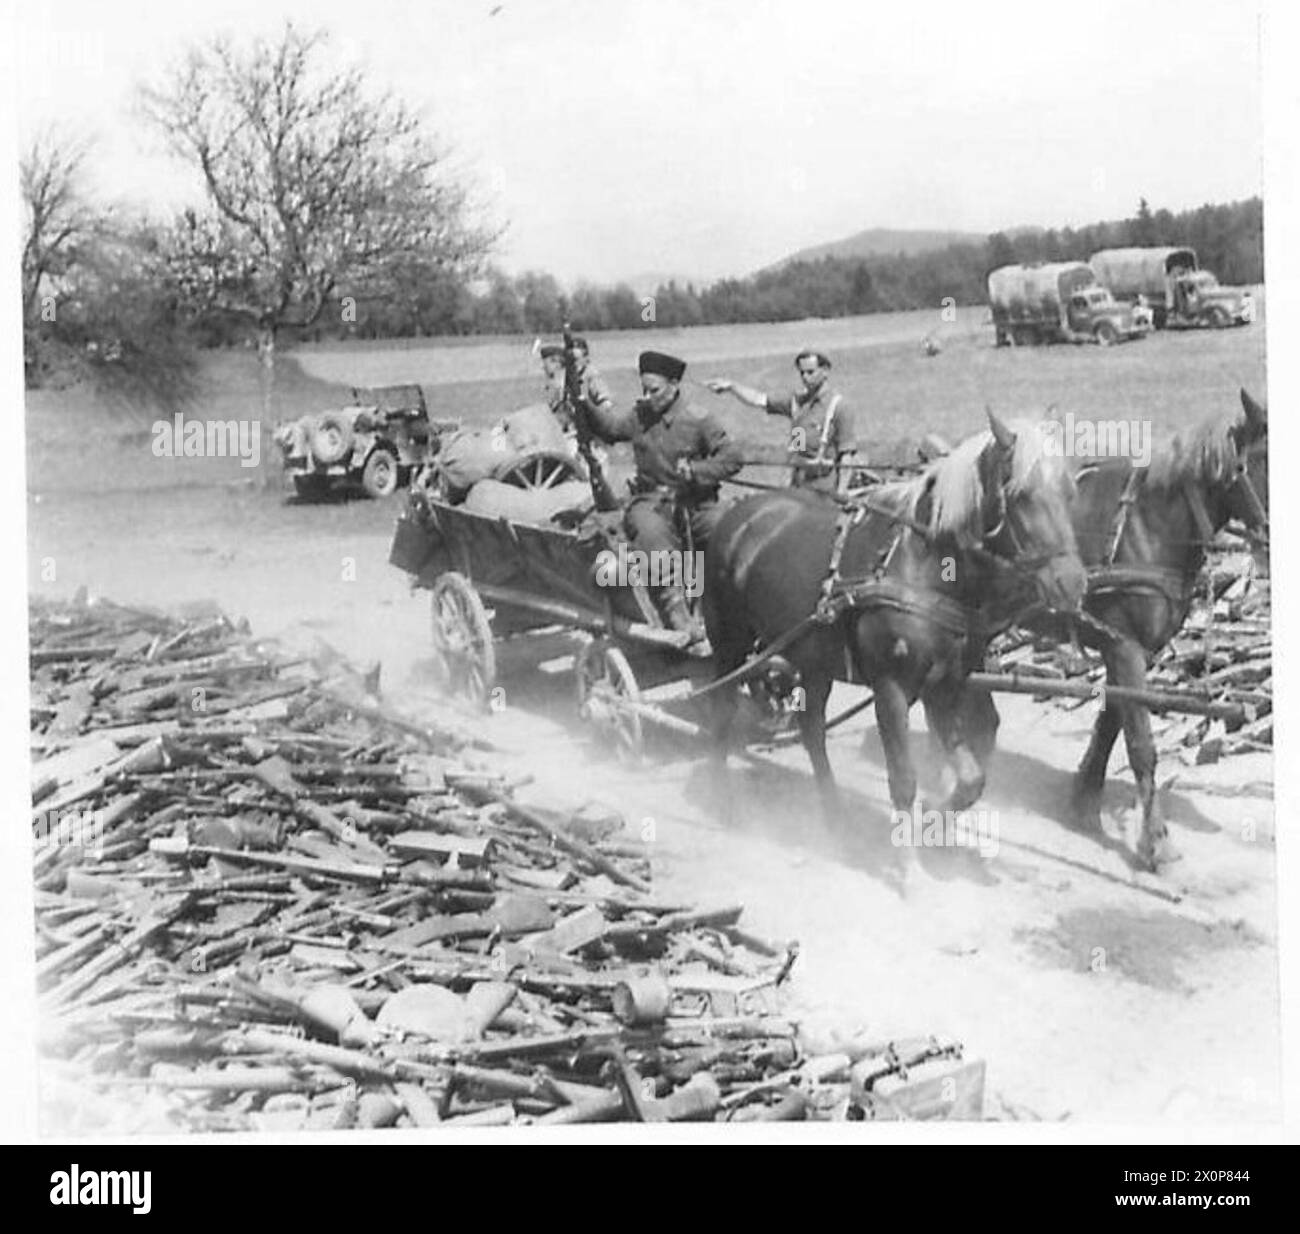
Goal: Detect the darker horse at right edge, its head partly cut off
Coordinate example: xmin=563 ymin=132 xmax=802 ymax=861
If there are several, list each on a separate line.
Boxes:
xmin=962 ymin=390 xmax=1269 ymax=870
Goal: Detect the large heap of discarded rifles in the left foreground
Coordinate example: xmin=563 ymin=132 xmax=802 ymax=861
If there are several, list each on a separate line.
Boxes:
xmin=31 ymin=597 xmax=983 ymax=1134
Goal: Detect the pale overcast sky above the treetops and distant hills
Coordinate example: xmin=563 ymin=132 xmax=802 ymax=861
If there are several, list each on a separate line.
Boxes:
xmin=16 ymin=0 xmax=1261 ymax=282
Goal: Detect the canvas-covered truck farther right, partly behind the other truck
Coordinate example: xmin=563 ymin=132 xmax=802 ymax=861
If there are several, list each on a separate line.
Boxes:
xmin=1088 ymin=247 xmax=1255 ymax=330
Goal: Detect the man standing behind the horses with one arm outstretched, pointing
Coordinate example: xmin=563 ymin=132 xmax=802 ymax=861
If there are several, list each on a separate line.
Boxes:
xmin=709 ymin=348 xmax=866 ymax=493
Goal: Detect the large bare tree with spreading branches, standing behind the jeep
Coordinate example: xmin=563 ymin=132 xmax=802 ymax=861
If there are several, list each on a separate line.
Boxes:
xmin=142 ymin=23 xmax=497 ymax=427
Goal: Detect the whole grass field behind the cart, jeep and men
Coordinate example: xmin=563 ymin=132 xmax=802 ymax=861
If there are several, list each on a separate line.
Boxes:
xmin=27 ymin=302 xmax=1265 ymax=493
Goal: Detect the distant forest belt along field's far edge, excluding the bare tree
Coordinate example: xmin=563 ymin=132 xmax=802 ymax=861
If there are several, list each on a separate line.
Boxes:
xmin=292 ymin=198 xmax=1264 ymax=342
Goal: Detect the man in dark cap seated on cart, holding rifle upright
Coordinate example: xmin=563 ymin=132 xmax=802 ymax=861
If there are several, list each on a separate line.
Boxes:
xmin=580 ymin=351 xmax=742 ymax=654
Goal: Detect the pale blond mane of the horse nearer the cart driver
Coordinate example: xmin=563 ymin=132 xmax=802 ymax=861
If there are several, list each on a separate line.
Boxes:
xmin=899 ymin=420 xmax=1070 ymax=536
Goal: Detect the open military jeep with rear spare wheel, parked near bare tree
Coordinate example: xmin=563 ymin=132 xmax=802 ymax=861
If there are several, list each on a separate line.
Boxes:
xmin=276 ymin=385 xmax=458 ymax=498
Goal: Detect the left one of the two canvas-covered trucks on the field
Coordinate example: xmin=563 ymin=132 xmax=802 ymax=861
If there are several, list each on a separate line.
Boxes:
xmin=988 ymin=261 xmax=1151 ymax=347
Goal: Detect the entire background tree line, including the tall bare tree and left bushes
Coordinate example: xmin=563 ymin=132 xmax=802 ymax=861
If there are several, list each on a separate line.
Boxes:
xmin=21 ymin=23 xmax=1264 ymax=405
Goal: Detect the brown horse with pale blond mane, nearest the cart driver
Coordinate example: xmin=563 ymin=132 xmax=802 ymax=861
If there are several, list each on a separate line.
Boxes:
xmin=703 ymin=412 xmax=1086 ymax=813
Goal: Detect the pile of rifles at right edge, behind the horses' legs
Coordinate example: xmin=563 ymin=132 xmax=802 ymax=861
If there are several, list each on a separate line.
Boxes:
xmin=989 ymin=536 xmax=1273 ymax=763
